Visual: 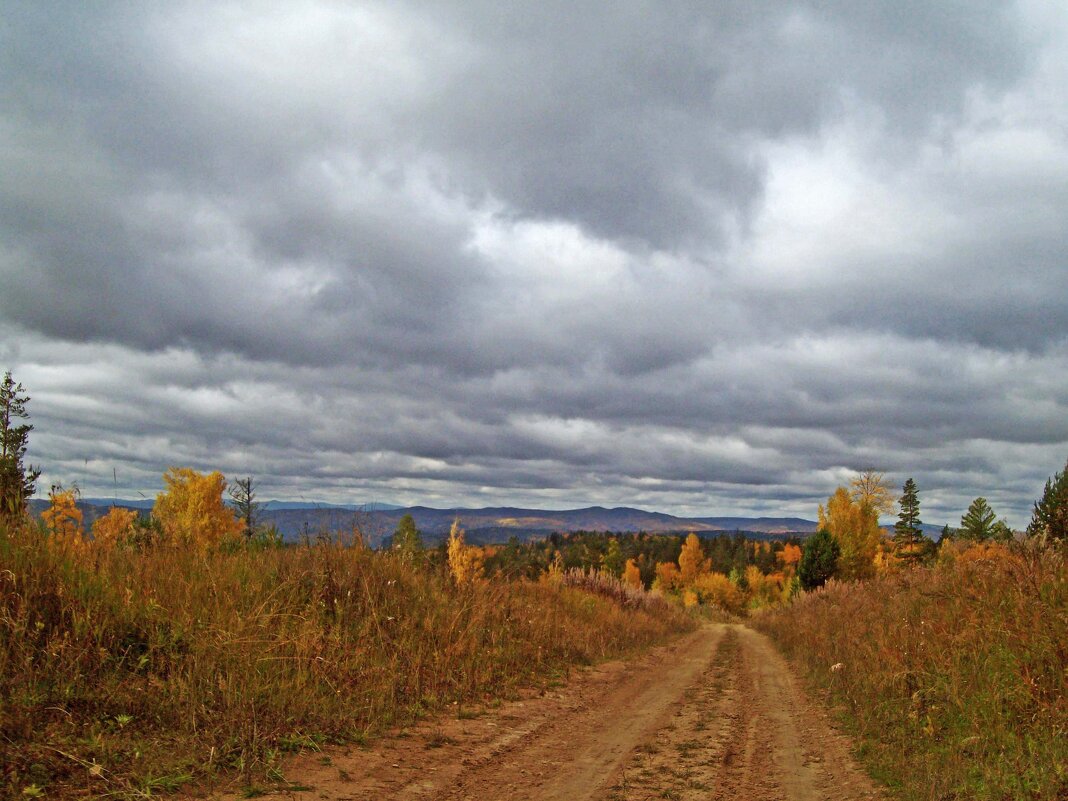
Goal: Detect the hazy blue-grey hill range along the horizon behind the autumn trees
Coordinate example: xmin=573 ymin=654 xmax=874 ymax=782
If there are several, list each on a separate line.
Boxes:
xmin=25 ymin=498 xmax=942 ymax=547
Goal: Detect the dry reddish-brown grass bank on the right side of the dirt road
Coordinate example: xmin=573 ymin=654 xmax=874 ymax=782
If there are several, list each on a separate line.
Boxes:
xmin=751 ymin=544 xmax=1068 ymax=801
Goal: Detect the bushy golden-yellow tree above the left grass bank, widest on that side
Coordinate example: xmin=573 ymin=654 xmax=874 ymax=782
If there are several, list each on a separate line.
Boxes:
xmin=152 ymin=468 xmax=242 ymax=549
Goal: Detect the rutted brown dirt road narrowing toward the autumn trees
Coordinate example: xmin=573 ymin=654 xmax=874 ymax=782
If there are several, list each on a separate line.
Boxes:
xmin=242 ymin=625 xmax=882 ymax=801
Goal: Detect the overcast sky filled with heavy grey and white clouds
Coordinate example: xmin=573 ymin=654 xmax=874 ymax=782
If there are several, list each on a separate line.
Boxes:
xmin=0 ymin=0 xmax=1068 ymax=527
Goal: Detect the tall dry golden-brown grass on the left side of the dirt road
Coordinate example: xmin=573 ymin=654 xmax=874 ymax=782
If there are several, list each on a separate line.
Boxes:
xmin=0 ymin=525 xmax=694 ymax=798
